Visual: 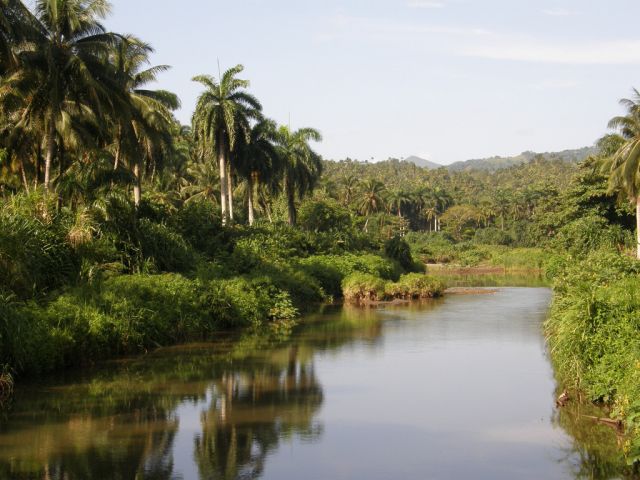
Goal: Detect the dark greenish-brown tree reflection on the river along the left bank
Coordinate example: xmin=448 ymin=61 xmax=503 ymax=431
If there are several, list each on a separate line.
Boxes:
xmin=0 ymin=309 xmax=381 ymax=479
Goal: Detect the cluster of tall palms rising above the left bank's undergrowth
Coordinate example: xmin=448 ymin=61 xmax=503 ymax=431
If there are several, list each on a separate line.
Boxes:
xmin=0 ymin=0 xmax=322 ymax=228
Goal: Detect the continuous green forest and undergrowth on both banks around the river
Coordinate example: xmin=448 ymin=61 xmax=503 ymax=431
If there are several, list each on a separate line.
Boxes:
xmin=0 ymin=0 xmax=640 ymax=472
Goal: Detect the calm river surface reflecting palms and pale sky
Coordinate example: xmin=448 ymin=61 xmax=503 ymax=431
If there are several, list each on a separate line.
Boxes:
xmin=0 ymin=288 xmax=624 ymax=480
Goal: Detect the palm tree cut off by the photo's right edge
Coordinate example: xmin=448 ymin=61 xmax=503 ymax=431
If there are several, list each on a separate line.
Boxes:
xmin=603 ymin=88 xmax=640 ymax=259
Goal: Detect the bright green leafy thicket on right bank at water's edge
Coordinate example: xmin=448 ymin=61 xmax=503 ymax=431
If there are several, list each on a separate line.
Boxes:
xmin=545 ymin=251 xmax=640 ymax=461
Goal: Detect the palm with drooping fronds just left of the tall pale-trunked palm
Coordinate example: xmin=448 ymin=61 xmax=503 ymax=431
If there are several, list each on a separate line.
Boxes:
xmin=111 ymin=35 xmax=180 ymax=207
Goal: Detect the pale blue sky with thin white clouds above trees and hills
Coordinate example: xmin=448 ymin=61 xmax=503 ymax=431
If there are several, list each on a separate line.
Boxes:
xmin=105 ymin=0 xmax=640 ymax=164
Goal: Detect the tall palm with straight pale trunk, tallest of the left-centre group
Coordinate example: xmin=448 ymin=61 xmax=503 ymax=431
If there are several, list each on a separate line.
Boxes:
xmin=192 ymin=65 xmax=262 ymax=224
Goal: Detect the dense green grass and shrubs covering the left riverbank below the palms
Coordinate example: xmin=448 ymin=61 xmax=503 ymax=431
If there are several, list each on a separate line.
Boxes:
xmin=0 ymin=191 xmax=420 ymax=378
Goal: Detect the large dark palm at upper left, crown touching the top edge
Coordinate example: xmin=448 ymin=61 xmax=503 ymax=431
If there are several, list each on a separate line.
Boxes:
xmin=8 ymin=0 xmax=125 ymax=191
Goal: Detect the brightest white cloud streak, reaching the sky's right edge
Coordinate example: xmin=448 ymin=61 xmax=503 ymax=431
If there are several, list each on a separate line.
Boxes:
xmin=460 ymin=37 xmax=640 ymax=65
